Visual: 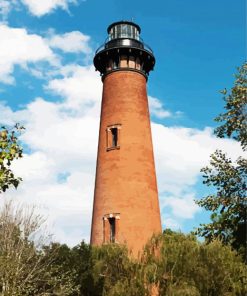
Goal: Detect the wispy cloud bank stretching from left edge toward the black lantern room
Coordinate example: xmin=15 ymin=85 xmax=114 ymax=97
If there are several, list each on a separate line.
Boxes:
xmin=0 ymin=24 xmax=92 ymax=84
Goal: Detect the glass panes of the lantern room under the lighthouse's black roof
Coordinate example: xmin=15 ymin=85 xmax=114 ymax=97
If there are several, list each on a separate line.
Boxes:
xmin=109 ymin=23 xmax=140 ymax=40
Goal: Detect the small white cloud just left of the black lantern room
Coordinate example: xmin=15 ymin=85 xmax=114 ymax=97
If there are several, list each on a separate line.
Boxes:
xmin=48 ymin=31 xmax=92 ymax=54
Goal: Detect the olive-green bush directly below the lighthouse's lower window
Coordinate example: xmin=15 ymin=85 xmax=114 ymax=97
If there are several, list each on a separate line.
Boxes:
xmin=93 ymin=244 xmax=149 ymax=296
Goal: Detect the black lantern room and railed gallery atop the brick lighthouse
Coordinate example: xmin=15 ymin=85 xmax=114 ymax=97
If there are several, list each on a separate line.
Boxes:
xmin=94 ymin=21 xmax=155 ymax=79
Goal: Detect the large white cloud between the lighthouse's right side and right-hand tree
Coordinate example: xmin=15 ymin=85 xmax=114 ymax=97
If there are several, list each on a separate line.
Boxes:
xmin=152 ymin=123 xmax=241 ymax=194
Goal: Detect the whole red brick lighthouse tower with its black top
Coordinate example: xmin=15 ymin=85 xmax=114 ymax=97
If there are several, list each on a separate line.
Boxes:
xmin=91 ymin=21 xmax=161 ymax=255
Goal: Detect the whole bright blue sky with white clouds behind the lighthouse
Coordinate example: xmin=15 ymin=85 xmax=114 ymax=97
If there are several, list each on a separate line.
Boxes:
xmin=0 ymin=0 xmax=246 ymax=246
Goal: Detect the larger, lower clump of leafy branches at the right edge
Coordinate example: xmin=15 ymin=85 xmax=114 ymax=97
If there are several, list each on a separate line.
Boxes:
xmin=196 ymin=150 xmax=247 ymax=253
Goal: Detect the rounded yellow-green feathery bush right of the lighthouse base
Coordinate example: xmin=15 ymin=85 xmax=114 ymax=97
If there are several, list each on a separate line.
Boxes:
xmin=144 ymin=231 xmax=247 ymax=296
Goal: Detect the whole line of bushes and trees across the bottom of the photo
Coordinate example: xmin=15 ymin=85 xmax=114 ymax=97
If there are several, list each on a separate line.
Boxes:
xmin=0 ymin=202 xmax=247 ymax=296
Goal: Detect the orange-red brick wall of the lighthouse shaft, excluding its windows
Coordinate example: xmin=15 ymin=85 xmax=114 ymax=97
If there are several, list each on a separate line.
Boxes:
xmin=91 ymin=70 xmax=161 ymax=256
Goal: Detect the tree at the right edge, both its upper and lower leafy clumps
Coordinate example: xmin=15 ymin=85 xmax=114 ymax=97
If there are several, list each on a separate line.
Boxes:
xmin=196 ymin=63 xmax=247 ymax=260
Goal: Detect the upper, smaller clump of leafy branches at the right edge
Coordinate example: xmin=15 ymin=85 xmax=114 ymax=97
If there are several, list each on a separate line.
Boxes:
xmin=215 ymin=63 xmax=247 ymax=150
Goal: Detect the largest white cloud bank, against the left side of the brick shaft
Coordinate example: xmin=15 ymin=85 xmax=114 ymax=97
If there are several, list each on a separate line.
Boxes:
xmin=0 ymin=66 xmax=102 ymax=245
